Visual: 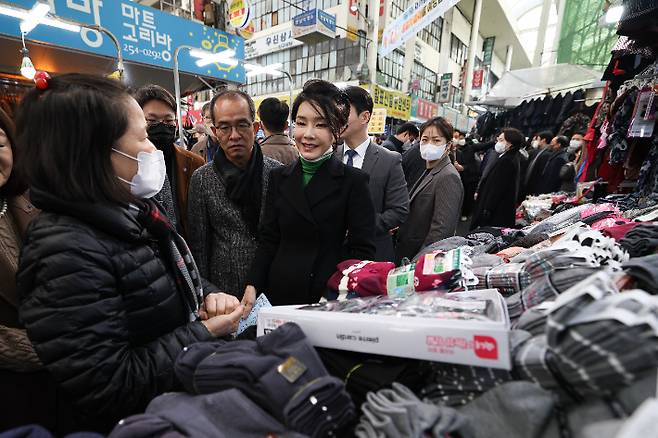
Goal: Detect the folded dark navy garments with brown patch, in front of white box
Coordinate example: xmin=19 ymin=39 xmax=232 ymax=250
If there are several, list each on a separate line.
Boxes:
xmin=176 ymin=323 xmax=356 ymax=436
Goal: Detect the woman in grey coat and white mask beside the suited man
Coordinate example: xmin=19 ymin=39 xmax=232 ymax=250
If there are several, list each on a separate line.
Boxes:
xmin=397 ymin=117 xmax=464 ymax=262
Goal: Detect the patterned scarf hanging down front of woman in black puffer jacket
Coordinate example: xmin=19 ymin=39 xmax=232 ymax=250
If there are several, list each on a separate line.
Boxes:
xmin=137 ymin=199 xmax=203 ymax=321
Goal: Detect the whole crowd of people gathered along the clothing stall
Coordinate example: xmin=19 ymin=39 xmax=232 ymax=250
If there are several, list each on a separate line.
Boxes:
xmin=0 ymin=70 xmax=582 ymax=433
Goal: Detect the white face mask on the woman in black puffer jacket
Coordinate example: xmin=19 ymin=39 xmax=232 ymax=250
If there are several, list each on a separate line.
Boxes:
xmin=112 ymin=148 xmax=167 ymax=199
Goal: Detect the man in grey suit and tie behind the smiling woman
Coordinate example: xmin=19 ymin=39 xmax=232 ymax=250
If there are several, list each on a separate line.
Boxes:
xmin=337 ymin=86 xmax=409 ymax=261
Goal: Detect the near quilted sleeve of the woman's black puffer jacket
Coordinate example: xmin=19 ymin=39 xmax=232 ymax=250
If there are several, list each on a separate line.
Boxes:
xmin=17 ymin=223 xmax=211 ymax=421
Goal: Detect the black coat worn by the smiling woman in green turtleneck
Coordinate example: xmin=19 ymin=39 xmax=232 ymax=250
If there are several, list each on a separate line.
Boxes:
xmin=248 ymin=157 xmax=375 ymax=305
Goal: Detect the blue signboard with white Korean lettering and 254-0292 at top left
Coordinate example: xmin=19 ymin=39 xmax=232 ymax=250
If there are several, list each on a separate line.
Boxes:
xmin=0 ymin=0 xmax=245 ymax=83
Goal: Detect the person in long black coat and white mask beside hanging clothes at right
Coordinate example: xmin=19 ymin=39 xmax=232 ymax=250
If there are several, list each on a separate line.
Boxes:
xmin=471 ymin=128 xmax=525 ymax=229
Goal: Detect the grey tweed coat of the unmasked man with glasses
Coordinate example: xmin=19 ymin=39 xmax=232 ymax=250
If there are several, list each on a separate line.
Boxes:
xmin=188 ymin=157 xmax=281 ymax=298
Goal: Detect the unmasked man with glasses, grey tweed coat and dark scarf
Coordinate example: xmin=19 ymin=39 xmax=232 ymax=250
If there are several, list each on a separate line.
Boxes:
xmin=188 ymin=90 xmax=281 ymax=298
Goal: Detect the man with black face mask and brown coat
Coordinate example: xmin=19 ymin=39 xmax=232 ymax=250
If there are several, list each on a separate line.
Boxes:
xmin=133 ymin=85 xmax=204 ymax=237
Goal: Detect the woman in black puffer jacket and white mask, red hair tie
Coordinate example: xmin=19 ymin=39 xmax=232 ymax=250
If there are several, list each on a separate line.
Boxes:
xmin=17 ymin=74 xmax=242 ymax=431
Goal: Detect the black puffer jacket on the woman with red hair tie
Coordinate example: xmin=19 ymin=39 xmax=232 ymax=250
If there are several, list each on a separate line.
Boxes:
xmin=17 ymin=190 xmax=212 ymax=430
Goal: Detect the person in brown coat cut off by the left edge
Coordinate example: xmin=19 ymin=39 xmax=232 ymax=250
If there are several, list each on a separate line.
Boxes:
xmin=0 ymin=109 xmax=56 ymax=430
